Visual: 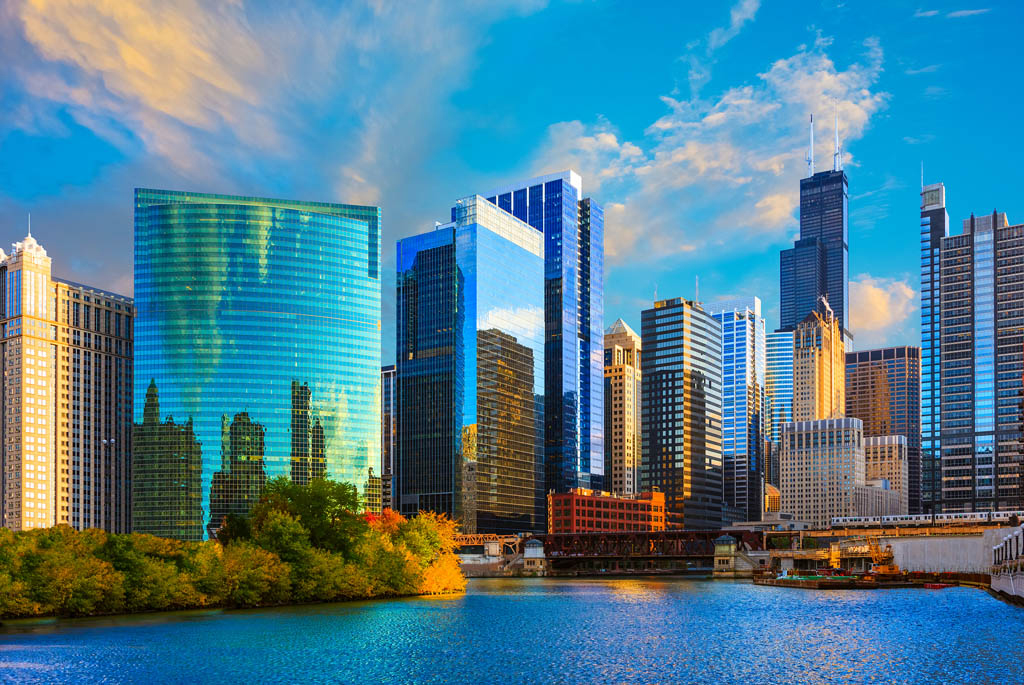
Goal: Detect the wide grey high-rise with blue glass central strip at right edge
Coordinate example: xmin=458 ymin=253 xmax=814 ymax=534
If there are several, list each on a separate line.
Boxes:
xmin=933 ymin=212 xmax=1024 ymax=512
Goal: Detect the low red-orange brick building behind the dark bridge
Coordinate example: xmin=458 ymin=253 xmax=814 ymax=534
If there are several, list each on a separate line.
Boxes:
xmin=548 ymin=487 xmax=667 ymax=533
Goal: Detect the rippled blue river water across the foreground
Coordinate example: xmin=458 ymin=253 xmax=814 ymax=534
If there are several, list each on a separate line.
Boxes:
xmin=0 ymin=579 xmax=1024 ymax=684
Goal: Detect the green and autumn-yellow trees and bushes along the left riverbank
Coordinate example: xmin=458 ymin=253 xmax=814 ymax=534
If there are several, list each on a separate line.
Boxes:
xmin=0 ymin=478 xmax=466 ymax=619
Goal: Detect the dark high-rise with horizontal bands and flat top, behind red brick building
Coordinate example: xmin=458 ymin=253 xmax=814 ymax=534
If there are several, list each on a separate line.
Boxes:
xmin=640 ymin=298 xmax=722 ymax=528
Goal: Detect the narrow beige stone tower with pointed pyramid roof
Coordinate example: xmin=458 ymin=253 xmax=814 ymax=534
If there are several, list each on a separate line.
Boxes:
xmin=604 ymin=318 xmax=642 ymax=495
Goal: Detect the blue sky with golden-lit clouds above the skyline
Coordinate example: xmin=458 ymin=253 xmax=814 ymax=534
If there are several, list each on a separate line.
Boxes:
xmin=0 ymin=0 xmax=1024 ymax=360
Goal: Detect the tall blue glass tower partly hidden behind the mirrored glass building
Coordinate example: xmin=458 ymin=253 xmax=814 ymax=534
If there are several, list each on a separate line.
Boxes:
xmin=473 ymin=171 xmax=605 ymax=493
